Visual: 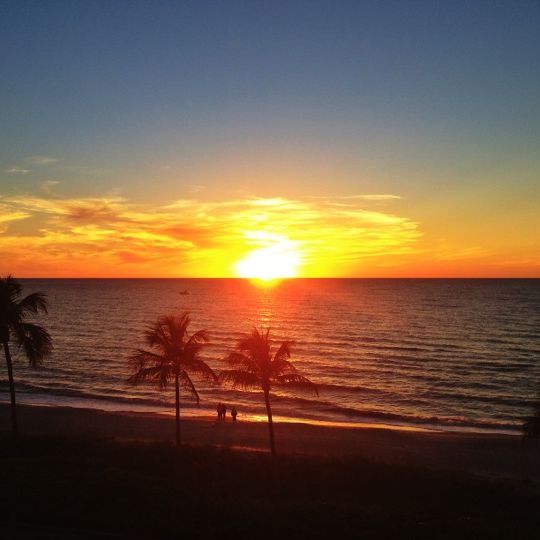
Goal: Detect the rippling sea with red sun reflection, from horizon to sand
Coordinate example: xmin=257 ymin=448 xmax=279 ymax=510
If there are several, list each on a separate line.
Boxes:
xmin=0 ymin=279 xmax=540 ymax=432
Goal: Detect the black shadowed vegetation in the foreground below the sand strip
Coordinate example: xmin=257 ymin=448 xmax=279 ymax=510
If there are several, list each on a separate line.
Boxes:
xmin=0 ymin=435 xmax=540 ymax=539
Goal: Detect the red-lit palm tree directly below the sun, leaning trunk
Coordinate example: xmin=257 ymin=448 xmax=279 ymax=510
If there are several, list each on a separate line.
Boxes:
xmin=220 ymin=328 xmax=319 ymax=456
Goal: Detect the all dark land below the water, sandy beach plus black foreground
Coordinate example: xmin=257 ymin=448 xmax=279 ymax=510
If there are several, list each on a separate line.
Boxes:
xmin=0 ymin=405 xmax=540 ymax=539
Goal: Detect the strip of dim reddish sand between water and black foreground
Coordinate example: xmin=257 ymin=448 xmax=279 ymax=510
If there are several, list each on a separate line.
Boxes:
xmin=0 ymin=403 xmax=540 ymax=483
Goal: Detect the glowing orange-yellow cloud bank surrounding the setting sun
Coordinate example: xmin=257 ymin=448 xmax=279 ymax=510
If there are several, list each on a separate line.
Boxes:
xmin=0 ymin=193 xmax=422 ymax=276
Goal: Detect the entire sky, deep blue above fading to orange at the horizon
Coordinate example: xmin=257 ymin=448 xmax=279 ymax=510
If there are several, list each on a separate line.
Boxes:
xmin=0 ymin=0 xmax=540 ymax=277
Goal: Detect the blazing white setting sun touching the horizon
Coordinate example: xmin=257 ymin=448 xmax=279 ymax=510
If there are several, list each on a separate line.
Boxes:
xmin=236 ymin=242 xmax=300 ymax=281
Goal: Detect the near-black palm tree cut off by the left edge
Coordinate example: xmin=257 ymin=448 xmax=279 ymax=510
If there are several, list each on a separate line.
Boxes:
xmin=0 ymin=276 xmax=52 ymax=436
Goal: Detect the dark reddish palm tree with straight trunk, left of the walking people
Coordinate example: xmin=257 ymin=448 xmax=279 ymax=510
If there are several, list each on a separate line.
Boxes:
xmin=128 ymin=313 xmax=217 ymax=447
